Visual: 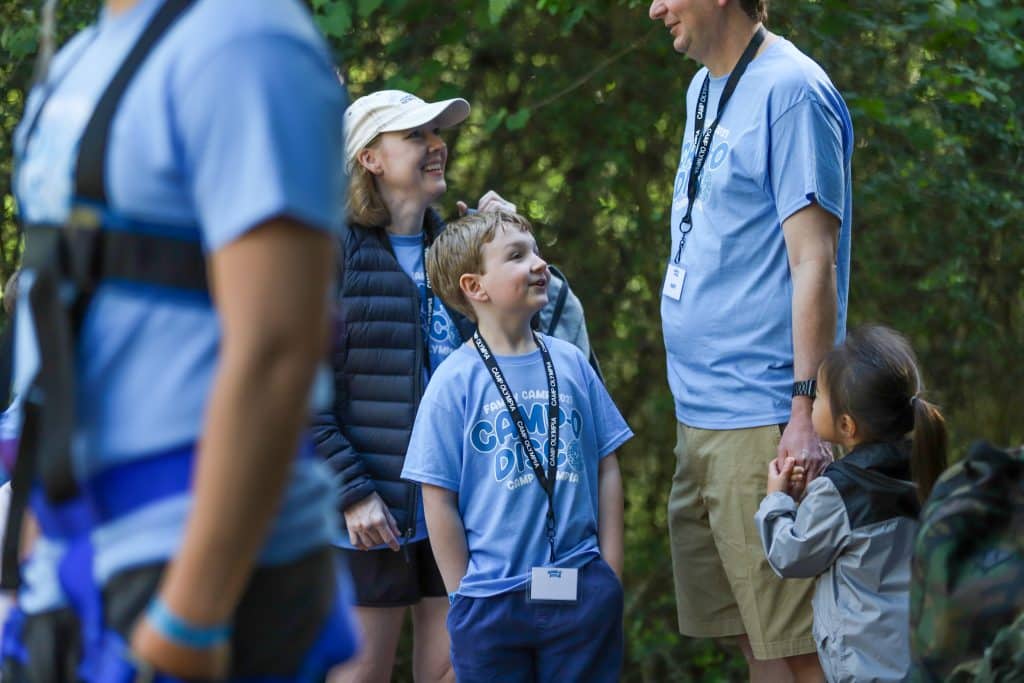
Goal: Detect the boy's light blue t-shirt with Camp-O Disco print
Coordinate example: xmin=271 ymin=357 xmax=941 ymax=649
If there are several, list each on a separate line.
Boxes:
xmin=401 ymin=336 xmax=633 ymax=597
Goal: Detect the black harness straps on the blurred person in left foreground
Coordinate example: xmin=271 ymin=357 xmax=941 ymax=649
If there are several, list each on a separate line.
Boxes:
xmin=2 ymin=0 xmax=198 ymax=588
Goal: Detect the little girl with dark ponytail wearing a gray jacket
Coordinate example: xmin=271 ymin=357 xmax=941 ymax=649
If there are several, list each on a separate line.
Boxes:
xmin=756 ymin=326 xmax=946 ymax=681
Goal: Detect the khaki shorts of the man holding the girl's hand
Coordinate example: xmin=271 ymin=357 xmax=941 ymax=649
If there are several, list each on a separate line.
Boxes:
xmin=669 ymin=423 xmax=815 ymax=659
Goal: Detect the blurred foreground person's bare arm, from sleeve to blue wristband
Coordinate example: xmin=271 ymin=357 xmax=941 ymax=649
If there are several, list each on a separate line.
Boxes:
xmin=153 ymin=219 xmax=334 ymax=625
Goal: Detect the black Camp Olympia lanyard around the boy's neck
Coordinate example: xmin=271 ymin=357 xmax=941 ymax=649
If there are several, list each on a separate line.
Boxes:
xmin=473 ymin=331 xmax=558 ymax=562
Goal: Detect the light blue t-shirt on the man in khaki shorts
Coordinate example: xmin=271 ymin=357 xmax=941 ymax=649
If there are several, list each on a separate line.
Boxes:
xmin=662 ymin=39 xmax=853 ymax=429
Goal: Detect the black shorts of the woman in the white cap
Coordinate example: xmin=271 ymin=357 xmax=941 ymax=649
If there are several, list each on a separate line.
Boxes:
xmin=338 ymin=540 xmax=447 ymax=607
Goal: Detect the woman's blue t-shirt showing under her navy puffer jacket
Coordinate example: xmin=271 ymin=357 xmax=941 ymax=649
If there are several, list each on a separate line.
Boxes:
xmin=335 ymin=232 xmax=462 ymax=550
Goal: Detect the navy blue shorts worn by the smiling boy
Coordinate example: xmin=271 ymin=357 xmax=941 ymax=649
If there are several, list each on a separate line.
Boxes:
xmin=447 ymin=558 xmax=623 ymax=683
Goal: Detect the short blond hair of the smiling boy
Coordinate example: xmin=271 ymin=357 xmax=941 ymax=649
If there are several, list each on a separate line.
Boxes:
xmin=427 ymin=211 xmax=534 ymax=321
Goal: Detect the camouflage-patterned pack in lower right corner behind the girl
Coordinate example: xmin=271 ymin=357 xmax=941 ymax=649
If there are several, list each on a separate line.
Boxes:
xmin=910 ymin=442 xmax=1024 ymax=681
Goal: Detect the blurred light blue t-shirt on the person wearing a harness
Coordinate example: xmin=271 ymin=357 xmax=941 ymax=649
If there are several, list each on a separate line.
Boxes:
xmin=14 ymin=0 xmax=345 ymax=593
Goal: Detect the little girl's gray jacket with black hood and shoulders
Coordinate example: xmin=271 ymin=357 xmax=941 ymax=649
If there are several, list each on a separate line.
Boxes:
xmin=755 ymin=442 xmax=920 ymax=683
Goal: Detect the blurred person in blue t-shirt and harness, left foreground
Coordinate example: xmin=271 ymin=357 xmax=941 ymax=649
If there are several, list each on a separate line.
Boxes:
xmin=15 ymin=0 xmax=352 ymax=680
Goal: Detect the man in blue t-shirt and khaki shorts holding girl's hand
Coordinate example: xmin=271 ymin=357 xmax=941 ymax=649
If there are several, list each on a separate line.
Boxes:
xmin=649 ymin=0 xmax=853 ymax=681
